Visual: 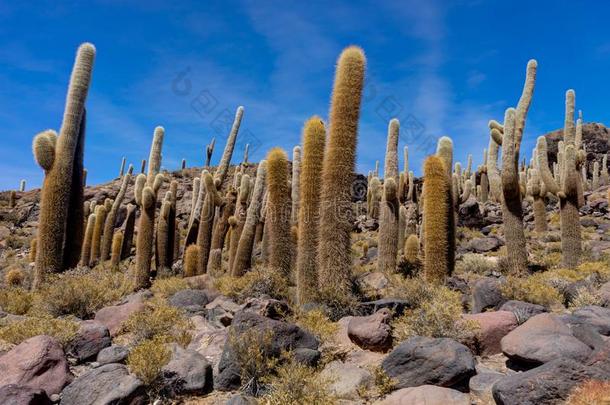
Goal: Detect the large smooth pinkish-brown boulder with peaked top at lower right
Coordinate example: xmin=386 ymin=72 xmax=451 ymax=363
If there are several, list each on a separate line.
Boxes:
xmin=500 ymin=314 xmax=591 ymax=368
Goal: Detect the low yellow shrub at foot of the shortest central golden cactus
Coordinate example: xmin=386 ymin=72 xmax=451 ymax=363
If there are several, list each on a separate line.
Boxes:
xmin=214 ymin=268 xmax=288 ymax=302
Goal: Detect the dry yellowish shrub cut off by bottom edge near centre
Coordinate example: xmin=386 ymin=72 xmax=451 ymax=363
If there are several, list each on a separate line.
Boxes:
xmin=262 ymin=361 xmax=337 ymax=405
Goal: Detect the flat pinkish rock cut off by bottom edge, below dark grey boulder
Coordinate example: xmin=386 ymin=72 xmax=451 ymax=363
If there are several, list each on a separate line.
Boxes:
xmin=375 ymin=385 xmax=470 ymax=405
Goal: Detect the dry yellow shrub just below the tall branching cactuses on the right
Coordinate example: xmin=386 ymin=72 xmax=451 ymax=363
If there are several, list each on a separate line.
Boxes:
xmin=501 ymin=273 xmax=563 ymax=307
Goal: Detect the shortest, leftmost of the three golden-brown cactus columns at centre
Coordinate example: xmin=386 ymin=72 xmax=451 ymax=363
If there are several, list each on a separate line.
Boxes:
xmin=266 ymin=148 xmax=293 ymax=277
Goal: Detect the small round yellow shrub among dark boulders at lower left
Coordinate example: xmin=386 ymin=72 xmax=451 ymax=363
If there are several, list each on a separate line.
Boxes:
xmin=127 ymin=339 xmax=172 ymax=385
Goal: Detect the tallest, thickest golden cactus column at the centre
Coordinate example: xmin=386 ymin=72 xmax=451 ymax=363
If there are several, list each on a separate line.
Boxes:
xmin=318 ymin=47 xmax=366 ymax=302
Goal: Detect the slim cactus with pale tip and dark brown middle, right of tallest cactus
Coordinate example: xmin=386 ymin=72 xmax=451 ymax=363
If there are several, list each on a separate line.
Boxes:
xmin=377 ymin=119 xmax=400 ymax=273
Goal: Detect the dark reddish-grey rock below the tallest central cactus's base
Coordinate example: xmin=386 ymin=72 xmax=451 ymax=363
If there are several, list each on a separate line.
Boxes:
xmin=347 ymin=308 xmax=392 ymax=352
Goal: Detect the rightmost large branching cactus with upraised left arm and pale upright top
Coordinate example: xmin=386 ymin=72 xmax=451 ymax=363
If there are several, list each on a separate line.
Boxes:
xmin=536 ymin=90 xmax=586 ymax=268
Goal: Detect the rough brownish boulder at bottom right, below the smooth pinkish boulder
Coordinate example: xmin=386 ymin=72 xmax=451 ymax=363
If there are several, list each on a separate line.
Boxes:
xmin=492 ymin=356 xmax=596 ymax=405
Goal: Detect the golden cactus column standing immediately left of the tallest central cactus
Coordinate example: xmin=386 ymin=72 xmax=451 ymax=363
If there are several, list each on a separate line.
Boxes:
xmin=296 ymin=116 xmax=326 ymax=305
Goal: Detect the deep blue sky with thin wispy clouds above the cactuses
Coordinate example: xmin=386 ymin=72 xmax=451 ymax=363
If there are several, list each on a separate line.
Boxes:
xmin=0 ymin=0 xmax=610 ymax=189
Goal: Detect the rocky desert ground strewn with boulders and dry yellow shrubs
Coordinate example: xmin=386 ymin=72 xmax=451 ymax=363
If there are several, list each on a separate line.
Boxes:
xmin=0 ymin=154 xmax=610 ymax=405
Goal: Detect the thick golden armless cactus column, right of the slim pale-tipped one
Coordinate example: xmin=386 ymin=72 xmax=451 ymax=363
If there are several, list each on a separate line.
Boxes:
xmin=423 ymin=156 xmax=453 ymax=284
